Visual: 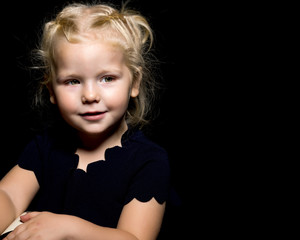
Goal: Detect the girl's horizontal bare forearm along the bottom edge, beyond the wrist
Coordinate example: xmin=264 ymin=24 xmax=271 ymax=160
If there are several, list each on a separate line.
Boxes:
xmin=65 ymin=216 xmax=138 ymax=240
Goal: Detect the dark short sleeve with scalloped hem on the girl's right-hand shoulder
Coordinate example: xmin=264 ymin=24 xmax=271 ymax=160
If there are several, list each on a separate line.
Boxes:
xmin=125 ymin=148 xmax=170 ymax=204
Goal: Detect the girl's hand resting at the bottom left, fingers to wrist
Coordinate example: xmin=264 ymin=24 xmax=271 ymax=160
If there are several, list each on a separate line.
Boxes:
xmin=3 ymin=212 xmax=66 ymax=240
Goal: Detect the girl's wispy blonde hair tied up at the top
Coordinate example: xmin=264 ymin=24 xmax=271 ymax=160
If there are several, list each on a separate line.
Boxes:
xmin=35 ymin=3 xmax=156 ymax=126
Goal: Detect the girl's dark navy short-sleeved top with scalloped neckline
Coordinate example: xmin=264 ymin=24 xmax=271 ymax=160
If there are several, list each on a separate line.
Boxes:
xmin=18 ymin=125 xmax=170 ymax=227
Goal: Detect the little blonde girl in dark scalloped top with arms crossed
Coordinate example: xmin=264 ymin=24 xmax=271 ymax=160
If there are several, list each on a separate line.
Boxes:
xmin=0 ymin=3 xmax=170 ymax=240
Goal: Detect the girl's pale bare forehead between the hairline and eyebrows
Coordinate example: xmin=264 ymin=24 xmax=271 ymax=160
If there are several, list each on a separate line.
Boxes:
xmin=51 ymin=29 xmax=131 ymax=78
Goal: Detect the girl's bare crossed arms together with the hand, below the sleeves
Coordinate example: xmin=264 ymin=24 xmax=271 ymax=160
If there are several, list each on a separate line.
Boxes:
xmin=0 ymin=166 xmax=165 ymax=240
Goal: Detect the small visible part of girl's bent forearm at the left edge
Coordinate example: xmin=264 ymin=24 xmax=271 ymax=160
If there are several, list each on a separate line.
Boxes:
xmin=0 ymin=189 xmax=17 ymax=234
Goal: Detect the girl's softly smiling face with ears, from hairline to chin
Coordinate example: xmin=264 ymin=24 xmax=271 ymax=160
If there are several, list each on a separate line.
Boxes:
xmin=49 ymin=40 xmax=139 ymax=138
